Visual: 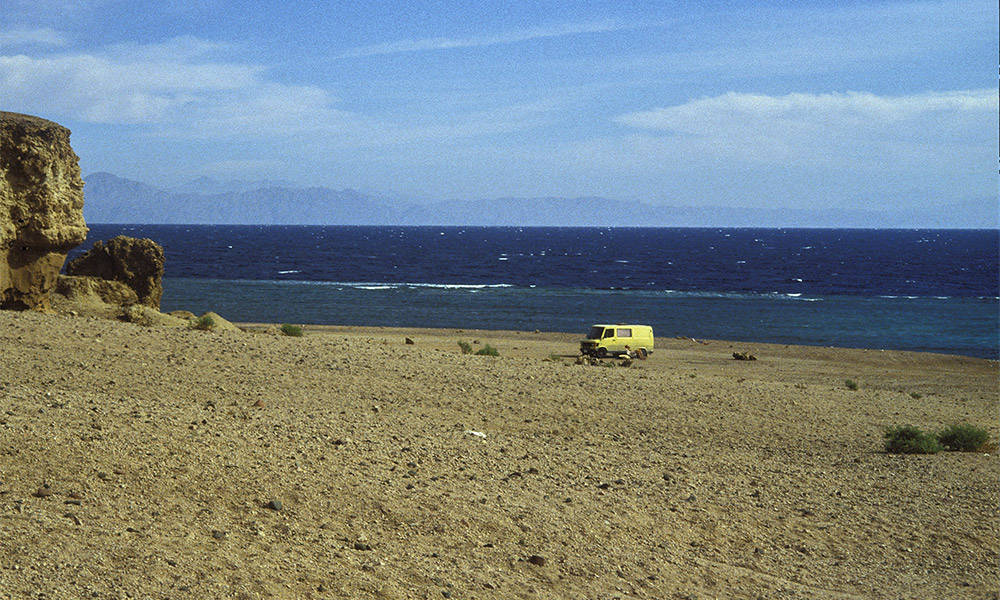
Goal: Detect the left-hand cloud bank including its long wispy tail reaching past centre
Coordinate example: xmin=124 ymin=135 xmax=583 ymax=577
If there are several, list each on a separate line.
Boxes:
xmin=0 ymin=37 xmax=559 ymax=148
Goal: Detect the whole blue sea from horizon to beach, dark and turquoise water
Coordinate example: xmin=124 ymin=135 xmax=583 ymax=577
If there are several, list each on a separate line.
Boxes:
xmin=73 ymin=225 xmax=1000 ymax=359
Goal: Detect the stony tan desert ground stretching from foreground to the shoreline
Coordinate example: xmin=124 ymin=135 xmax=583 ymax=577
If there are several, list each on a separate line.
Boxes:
xmin=0 ymin=312 xmax=1000 ymax=599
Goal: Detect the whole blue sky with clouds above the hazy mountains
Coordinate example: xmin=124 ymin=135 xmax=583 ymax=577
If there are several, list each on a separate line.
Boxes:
xmin=0 ymin=0 xmax=998 ymax=216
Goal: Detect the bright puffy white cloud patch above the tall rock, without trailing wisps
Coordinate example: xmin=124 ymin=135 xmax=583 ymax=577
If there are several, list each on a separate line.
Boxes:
xmin=0 ymin=37 xmax=324 ymax=126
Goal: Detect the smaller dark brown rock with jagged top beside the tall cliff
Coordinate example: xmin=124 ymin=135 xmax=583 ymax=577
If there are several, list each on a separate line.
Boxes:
xmin=66 ymin=235 xmax=163 ymax=309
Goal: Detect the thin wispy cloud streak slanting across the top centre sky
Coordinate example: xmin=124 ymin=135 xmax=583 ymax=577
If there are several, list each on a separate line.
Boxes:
xmin=336 ymin=20 xmax=644 ymax=58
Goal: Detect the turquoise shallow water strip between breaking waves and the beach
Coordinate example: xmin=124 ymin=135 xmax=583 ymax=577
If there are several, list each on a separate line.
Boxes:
xmin=162 ymin=278 xmax=998 ymax=359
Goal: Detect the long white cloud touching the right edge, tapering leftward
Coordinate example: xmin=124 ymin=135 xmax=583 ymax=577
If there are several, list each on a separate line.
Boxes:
xmin=615 ymin=90 xmax=998 ymax=166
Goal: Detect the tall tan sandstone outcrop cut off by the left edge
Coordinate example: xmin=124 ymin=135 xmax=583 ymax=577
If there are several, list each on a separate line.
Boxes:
xmin=0 ymin=112 xmax=87 ymax=309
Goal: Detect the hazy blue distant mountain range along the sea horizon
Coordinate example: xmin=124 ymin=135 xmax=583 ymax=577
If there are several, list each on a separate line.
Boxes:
xmin=83 ymin=173 xmax=997 ymax=228
